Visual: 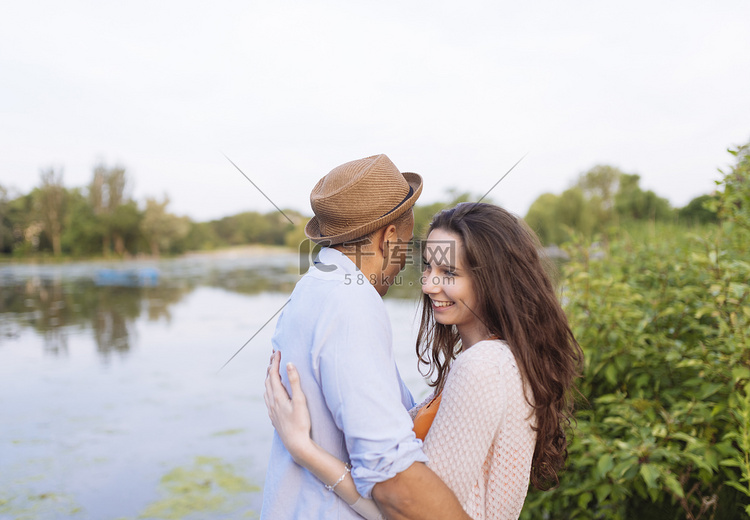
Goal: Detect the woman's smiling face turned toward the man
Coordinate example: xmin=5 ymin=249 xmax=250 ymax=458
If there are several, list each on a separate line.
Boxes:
xmin=422 ymin=229 xmax=484 ymax=338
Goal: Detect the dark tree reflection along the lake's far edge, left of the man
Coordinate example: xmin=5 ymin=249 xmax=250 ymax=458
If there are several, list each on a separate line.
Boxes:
xmin=0 ymin=251 xmax=306 ymax=362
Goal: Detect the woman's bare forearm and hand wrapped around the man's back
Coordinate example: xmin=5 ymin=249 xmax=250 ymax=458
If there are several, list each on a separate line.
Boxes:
xmin=263 ymin=351 xmax=383 ymax=520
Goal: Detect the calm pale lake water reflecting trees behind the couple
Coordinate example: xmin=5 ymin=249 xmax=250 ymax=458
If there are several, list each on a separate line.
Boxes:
xmin=0 ymin=253 xmax=426 ymax=520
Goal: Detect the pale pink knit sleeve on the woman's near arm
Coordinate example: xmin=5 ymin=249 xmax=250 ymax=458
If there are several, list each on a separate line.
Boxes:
xmin=424 ymin=345 xmax=507 ymax=504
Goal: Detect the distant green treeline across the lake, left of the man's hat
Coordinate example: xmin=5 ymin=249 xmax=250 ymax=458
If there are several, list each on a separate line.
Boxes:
xmin=0 ymin=164 xmax=307 ymax=257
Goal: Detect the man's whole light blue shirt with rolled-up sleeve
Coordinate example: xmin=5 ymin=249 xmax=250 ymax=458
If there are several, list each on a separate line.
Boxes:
xmin=261 ymin=248 xmax=427 ymax=520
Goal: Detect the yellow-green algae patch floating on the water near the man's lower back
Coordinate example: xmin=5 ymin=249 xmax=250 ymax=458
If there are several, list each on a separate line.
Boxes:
xmin=140 ymin=457 xmax=260 ymax=520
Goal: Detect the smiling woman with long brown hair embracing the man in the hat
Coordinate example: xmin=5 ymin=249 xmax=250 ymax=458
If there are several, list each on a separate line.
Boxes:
xmin=266 ymin=203 xmax=583 ymax=519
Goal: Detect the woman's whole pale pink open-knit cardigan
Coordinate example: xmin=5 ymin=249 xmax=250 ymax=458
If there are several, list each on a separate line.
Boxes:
xmin=424 ymin=341 xmax=535 ymax=518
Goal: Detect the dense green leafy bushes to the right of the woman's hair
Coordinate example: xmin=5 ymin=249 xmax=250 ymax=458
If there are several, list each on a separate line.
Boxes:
xmin=524 ymin=219 xmax=750 ymax=520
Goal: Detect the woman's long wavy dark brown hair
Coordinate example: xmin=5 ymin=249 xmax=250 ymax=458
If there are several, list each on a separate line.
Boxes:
xmin=417 ymin=203 xmax=583 ymax=489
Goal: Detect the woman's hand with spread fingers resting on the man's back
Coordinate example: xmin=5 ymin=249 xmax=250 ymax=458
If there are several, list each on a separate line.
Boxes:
xmin=263 ymin=351 xmax=314 ymax=465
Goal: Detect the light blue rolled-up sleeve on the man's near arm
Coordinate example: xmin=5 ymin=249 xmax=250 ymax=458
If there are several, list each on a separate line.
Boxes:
xmin=314 ymin=285 xmax=427 ymax=498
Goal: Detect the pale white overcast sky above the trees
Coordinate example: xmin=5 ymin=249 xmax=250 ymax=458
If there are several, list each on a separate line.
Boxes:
xmin=0 ymin=0 xmax=750 ymax=220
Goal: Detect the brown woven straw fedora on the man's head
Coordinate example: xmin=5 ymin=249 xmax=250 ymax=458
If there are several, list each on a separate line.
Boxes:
xmin=305 ymin=154 xmax=422 ymax=246
